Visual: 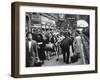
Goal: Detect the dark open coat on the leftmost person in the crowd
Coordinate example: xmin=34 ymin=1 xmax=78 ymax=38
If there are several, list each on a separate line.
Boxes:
xmin=26 ymin=40 xmax=36 ymax=67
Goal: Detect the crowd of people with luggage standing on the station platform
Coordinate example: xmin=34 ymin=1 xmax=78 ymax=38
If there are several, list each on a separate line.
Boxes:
xmin=26 ymin=29 xmax=86 ymax=67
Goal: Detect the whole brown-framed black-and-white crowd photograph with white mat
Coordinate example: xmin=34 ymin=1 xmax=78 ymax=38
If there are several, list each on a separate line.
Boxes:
xmin=11 ymin=2 xmax=97 ymax=78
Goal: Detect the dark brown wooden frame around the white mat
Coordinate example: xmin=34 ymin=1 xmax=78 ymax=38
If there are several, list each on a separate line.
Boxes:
xmin=11 ymin=2 xmax=98 ymax=78
